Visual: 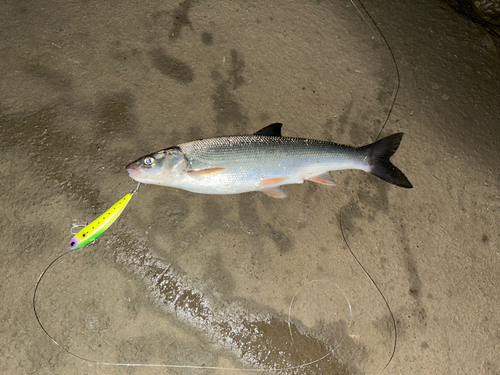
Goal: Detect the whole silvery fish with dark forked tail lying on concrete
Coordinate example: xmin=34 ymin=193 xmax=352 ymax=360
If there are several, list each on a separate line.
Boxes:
xmin=126 ymin=123 xmax=413 ymax=198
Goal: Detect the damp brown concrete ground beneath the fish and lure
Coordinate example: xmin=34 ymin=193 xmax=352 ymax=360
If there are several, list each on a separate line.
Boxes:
xmin=0 ymin=0 xmax=500 ymax=374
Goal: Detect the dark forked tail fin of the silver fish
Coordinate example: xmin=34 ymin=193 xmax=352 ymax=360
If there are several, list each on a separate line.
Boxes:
xmin=361 ymin=133 xmax=413 ymax=189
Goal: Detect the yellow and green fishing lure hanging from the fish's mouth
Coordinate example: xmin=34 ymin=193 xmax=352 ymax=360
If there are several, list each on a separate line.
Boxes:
xmin=69 ymin=185 xmax=139 ymax=250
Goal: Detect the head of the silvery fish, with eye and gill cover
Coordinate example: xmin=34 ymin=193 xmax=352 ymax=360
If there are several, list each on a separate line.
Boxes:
xmin=127 ymin=147 xmax=188 ymax=185
